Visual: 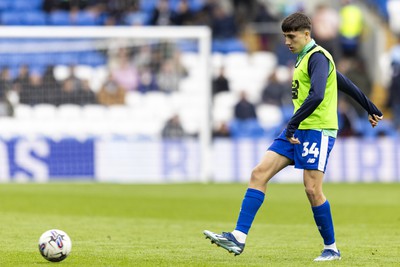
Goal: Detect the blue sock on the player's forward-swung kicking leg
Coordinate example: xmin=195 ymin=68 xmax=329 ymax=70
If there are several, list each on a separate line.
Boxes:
xmin=235 ymin=188 xmax=265 ymax=234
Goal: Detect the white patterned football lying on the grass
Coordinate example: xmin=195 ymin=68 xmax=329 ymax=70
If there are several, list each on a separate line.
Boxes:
xmin=39 ymin=229 xmax=72 ymax=262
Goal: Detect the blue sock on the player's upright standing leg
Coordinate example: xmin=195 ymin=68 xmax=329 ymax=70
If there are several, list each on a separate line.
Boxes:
xmin=312 ymin=200 xmax=335 ymax=245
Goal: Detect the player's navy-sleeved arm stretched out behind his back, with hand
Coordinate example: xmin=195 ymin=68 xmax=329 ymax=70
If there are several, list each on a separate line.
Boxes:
xmin=336 ymin=71 xmax=383 ymax=127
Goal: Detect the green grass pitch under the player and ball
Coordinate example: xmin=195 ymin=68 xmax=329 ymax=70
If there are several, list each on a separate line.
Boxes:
xmin=0 ymin=183 xmax=400 ymax=267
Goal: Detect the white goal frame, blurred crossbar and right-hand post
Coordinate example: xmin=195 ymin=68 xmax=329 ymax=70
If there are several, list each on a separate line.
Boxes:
xmin=0 ymin=26 xmax=212 ymax=182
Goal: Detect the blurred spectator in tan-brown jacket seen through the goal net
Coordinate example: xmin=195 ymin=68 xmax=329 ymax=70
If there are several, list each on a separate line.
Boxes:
xmin=97 ymin=75 xmax=126 ymax=106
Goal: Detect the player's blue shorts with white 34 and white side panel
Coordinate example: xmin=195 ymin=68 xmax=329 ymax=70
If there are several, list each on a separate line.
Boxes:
xmin=268 ymin=129 xmax=335 ymax=172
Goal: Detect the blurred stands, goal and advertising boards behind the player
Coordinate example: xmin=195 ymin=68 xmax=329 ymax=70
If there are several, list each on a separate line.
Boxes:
xmin=0 ymin=0 xmax=400 ymax=183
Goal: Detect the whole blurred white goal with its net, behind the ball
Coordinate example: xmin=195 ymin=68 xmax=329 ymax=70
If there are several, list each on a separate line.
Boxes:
xmin=0 ymin=27 xmax=211 ymax=183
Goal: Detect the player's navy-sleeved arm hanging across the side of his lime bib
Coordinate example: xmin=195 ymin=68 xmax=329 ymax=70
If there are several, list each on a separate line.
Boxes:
xmin=286 ymin=53 xmax=329 ymax=144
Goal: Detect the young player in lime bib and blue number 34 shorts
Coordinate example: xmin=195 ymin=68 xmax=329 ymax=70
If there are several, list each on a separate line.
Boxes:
xmin=204 ymin=13 xmax=383 ymax=261
